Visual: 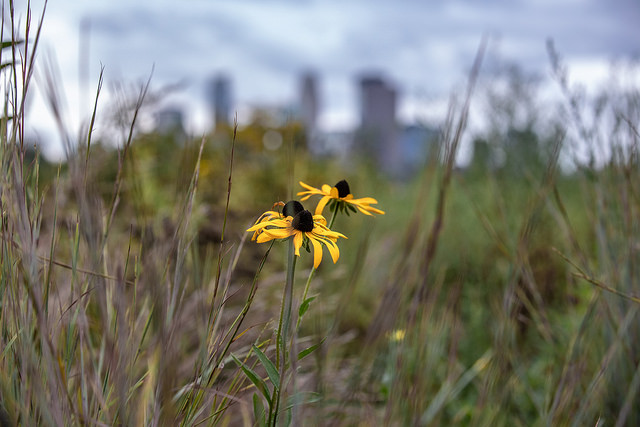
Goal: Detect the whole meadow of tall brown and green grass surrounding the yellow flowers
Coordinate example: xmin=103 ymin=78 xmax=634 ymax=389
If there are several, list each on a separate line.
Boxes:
xmin=0 ymin=7 xmax=640 ymax=426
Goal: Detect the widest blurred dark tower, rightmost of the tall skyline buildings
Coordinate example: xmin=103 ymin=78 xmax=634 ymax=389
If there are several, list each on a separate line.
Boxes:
xmin=354 ymin=76 xmax=401 ymax=172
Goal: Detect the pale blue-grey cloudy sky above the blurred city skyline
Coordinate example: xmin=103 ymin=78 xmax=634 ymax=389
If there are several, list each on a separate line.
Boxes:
xmin=10 ymin=0 xmax=640 ymax=160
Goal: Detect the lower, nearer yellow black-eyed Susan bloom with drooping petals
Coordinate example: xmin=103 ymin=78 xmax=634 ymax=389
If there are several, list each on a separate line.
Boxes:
xmin=247 ymin=201 xmax=347 ymax=268
